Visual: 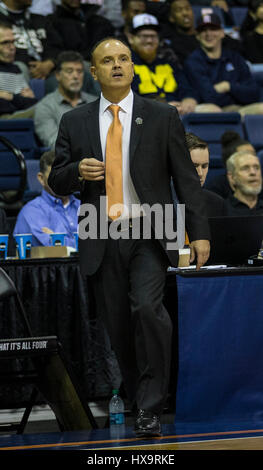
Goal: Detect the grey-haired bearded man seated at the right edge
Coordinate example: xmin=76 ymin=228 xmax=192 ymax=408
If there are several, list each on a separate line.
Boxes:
xmin=226 ymin=152 xmax=263 ymax=215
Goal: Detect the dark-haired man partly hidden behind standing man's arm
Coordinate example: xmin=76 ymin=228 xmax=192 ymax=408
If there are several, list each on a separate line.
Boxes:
xmin=185 ymin=132 xmax=226 ymax=217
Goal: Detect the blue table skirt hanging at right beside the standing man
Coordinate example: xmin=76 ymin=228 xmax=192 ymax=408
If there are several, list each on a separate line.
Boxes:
xmin=175 ymin=275 xmax=263 ymax=423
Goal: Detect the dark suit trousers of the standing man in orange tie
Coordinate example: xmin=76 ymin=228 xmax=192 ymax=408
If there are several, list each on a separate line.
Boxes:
xmin=91 ymin=235 xmax=172 ymax=413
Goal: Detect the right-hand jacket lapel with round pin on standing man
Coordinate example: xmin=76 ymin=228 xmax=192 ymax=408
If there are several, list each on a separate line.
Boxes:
xmin=130 ymin=93 xmax=146 ymax=164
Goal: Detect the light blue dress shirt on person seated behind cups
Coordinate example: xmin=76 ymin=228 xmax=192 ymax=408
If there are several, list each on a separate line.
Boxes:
xmin=14 ymin=190 xmax=80 ymax=248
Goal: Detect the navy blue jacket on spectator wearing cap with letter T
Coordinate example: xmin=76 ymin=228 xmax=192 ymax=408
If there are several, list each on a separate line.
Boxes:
xmin=184 ymin=47 xmax=260 ymax=107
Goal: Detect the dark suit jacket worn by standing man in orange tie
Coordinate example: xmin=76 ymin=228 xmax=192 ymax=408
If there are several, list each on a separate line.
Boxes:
xmin=49 ymin=95 xmax=210 ymax=275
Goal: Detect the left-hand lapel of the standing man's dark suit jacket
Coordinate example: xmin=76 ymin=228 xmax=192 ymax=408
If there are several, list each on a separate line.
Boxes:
xmin=87 ymin=99 xmax=103 ymax=161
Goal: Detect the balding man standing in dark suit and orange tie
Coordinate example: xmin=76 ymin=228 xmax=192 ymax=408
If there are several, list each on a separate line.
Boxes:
xmin=49 ymin=38 xmax=210 ymax=436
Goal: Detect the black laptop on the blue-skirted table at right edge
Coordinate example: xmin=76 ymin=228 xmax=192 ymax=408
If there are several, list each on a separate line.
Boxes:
xmin=206 ymin=215 xmax=263 ymax=266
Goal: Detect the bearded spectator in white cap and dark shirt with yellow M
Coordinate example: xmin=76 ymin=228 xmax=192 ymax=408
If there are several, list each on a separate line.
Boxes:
xmin=130 ymin=13 xmax=197 ymax=114
